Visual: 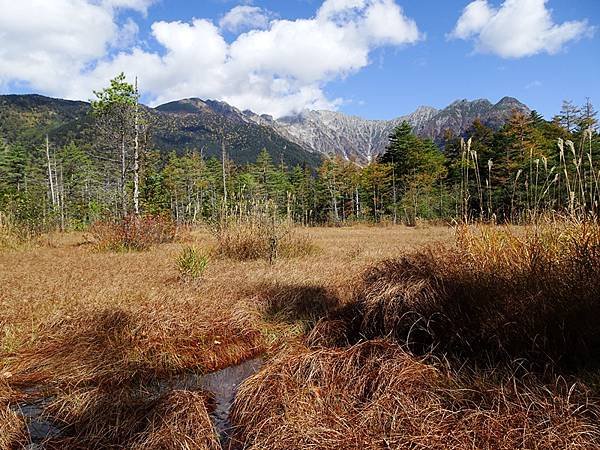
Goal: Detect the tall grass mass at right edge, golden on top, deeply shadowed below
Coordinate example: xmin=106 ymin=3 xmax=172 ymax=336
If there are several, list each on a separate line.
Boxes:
xmin=316 ymin=222 xmax=600 ymax=370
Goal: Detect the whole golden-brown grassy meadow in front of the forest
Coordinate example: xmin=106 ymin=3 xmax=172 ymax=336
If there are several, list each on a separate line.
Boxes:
xmin=0 ymin=220 xmax=600 ymax=450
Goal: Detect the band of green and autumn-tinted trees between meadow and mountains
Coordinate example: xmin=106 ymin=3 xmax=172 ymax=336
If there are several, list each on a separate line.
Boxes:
xmin=0 ymin=77 xmax=600 ymax=231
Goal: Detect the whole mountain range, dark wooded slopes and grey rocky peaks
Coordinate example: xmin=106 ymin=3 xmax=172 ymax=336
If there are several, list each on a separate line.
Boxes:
xmin=0 ymin=95 xmax=530 ymax=167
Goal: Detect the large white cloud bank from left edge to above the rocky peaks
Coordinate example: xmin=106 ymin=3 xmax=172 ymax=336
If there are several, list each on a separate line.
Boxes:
xmin=0 ymin=0 xmax=422 ymax=117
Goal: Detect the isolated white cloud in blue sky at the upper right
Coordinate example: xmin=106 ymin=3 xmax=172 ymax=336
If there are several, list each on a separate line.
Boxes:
xmin=450 ymin=0 xmax=594 ymax=58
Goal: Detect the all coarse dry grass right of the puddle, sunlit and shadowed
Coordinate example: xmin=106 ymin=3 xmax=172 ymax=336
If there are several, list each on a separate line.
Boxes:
xmin=226 ymin=222 xmax=600 ymax=450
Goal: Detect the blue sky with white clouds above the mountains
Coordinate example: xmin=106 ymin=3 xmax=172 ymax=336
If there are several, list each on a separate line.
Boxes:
xmin=0 ymin=0 xmax=600 ymax=119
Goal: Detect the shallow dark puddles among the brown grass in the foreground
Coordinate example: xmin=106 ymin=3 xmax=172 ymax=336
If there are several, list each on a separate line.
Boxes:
xmin=14 ymin=357 xmax=264 ymax=450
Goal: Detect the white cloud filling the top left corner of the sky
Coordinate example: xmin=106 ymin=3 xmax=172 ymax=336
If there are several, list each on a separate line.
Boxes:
xmin=0 ymin=0 xmax=118 ymax=94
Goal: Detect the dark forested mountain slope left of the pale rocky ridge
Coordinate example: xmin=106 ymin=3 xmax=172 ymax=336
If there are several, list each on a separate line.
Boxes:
xmin=0 ymin=95 xmax=321 ymax=167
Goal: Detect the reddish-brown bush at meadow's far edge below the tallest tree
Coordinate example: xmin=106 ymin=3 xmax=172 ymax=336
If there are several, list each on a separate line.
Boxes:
xmin=91 ymin=215 xmax=177 ymax=251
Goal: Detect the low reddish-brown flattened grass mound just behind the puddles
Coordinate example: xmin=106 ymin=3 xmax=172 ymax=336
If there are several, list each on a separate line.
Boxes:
xmin=11 ymin=302 xmax=261 ymax=385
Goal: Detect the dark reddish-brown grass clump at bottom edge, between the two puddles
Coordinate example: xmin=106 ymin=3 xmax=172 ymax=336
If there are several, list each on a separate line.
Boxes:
xmin=46 ymin=388 xmax=221 ymax=450
